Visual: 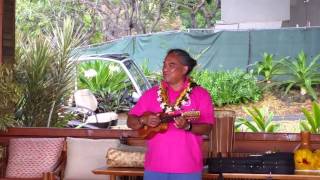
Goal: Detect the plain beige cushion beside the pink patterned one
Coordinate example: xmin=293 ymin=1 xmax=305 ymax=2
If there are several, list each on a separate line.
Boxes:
xmin=64 ymin=138 xmax=120 ymax=180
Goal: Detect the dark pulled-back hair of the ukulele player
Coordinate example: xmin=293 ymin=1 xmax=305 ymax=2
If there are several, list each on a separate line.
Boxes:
xmin=167 ymin=49 xmax=197 ymax=75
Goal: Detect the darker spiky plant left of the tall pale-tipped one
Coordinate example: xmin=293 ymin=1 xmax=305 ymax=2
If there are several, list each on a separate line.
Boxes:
xmin=18 ymin=37 xmax=54 ymax=126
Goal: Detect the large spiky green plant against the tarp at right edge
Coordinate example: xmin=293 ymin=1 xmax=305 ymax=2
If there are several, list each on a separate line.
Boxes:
xmin=278 ymin=51 xmax=320 ymax=100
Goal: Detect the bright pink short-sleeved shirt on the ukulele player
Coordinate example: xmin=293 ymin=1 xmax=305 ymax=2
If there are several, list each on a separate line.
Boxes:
xmin=129 ymin=81 xmax=215 ymax=173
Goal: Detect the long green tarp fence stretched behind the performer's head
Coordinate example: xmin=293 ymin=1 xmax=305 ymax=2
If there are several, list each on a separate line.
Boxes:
xmin=78 ymin=27 xmax=320 ymax=71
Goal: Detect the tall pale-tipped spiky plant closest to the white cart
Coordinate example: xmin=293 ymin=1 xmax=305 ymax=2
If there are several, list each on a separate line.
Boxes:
xmin=47 ymin=17 xmax=86 ymax=127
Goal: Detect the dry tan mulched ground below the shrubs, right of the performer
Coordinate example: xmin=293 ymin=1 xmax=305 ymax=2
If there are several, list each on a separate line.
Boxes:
xmin=216 ymin=88 xmax=320 ymax=133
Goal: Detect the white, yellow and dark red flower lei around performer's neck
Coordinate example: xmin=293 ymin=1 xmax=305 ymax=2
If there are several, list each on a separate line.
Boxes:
xmin=157 ymin=79 xmax=197 ymax=113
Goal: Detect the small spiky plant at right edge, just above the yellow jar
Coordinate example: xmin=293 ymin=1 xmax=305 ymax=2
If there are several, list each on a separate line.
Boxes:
xmin=300 ymin=101 xmax=320 ymax=133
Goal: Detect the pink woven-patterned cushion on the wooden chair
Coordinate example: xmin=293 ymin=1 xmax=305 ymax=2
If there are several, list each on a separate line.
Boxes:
xmin=6 ymin=138 xmax=64 ymax=178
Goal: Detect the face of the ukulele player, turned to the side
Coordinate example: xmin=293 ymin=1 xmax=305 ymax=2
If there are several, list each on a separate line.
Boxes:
xmin=162 ymin=53 xmax=188 ymax=84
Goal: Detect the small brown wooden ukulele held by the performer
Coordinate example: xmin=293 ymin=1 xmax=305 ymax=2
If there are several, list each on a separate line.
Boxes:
xmin=138 ymin=111 xmax=200 ymax=139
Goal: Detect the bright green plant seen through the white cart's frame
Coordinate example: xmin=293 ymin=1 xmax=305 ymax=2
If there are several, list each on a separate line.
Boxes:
xmin=78 ymin=60 xmax=130 ymax=112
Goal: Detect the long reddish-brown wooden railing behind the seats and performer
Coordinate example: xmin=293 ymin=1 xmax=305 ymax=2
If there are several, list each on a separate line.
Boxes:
xmin=0 ymin=128 xmax=320 ymax=154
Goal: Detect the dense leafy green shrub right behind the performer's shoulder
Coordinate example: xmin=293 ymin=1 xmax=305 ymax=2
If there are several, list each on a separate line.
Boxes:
xmin=192 ymin=70 xmax=262 ymax=106
